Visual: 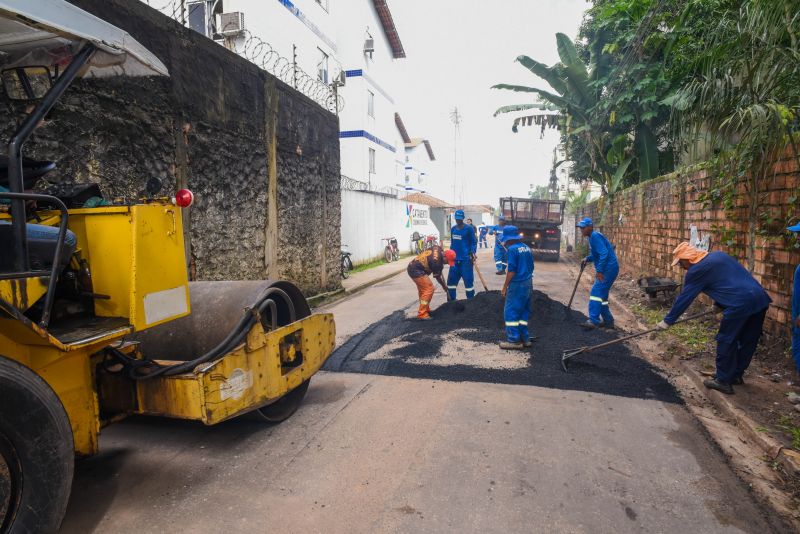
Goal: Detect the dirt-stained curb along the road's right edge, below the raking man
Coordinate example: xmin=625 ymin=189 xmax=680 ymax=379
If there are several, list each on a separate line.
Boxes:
xmin=564 ymin=262 xmax=800 ymax=475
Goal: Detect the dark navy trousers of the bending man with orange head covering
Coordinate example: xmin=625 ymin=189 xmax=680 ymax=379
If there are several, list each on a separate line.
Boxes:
xmin=716 ymin=308 xmax=767 ymax=384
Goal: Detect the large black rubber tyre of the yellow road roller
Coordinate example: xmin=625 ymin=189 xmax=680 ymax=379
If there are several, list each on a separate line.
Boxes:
xmin=0 ymin=356 xmax=75 ymax=533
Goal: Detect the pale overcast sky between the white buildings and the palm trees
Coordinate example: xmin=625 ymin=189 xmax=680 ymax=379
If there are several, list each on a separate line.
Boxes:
xmin=389 ymin=0 xmax=589 ymax=206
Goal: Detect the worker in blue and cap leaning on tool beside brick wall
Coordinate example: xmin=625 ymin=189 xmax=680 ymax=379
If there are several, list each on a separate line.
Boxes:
xmin=577 ymin=217 xmax=619 ymax=329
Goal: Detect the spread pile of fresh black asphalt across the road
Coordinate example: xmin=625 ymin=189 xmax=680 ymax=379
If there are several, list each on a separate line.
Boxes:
xmin=324 ymin=290 xmax=678 ymax=402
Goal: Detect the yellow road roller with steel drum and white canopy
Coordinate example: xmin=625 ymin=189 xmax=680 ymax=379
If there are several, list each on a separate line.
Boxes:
xmin=0 ymin=0 xmax=335 ymax=533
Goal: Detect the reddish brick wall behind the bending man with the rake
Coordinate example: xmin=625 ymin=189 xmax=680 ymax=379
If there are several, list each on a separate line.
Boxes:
xmin=583 ymin=151 xmax=800 ymax=336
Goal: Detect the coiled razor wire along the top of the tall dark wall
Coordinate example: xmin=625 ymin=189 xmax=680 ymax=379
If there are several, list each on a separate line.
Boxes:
xmin=142 ymin=0 xmax=344 ymax=114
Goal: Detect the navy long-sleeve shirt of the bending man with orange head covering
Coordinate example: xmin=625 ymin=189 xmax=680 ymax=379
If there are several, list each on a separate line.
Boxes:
xmin=664 ymin=251 xmax=772 ymax=325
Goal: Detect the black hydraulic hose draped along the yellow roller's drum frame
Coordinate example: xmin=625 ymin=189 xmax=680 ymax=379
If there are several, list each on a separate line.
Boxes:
xmin=108 ymin=287 xmax=297 ymax=380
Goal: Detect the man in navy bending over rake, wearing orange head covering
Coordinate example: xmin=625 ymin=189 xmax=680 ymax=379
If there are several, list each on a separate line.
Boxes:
xmin=658 ymin=242 xmax=772 ymax=394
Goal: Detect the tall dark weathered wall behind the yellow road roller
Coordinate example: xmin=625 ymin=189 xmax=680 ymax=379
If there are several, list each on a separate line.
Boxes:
xmin=0 ymin=0 xmax=341 ymax=294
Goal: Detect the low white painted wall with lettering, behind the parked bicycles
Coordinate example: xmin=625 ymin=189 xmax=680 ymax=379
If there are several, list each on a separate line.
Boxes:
xmin=342 ymin=191 xmax=439 ymax=264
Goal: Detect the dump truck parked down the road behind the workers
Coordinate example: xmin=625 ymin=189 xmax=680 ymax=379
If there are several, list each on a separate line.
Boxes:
xmin=500 ymin=197 xmax=565 ymax=261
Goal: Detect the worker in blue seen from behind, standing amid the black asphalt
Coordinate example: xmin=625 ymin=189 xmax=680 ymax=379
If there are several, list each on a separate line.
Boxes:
xmin=500 ymin=225 xmax=533 ymax=350
